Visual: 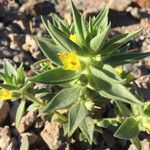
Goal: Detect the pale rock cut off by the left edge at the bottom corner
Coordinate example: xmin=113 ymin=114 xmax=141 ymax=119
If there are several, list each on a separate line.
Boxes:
xmin=0 ymin=126 xmax=11 ymax=150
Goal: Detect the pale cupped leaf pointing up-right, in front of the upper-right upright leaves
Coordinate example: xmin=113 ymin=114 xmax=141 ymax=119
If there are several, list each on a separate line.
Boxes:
xmin=90 ymin=24 xmax=110 ymax=52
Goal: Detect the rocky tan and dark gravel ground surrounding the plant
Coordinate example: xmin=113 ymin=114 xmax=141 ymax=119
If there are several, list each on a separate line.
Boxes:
xmin=0 ymin=0 xmax=150 ymax=150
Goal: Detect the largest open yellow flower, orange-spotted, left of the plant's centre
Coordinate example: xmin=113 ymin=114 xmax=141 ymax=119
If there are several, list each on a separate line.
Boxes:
xmin=58 ymin=52 xmax=81 ymax=70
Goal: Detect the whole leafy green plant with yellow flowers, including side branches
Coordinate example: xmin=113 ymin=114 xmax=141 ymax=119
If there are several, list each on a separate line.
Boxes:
xmin=0 ymin=2 xmax=150 ymax=149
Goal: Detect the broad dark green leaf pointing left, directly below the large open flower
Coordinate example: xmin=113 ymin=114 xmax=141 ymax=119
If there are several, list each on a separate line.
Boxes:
xmin=29 ymin=68 xmax=80 ymax=84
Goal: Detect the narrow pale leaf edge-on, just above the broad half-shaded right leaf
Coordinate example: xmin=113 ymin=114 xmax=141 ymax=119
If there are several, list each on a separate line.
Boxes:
xmin=90 ymin=66 xmax=123 ymax=83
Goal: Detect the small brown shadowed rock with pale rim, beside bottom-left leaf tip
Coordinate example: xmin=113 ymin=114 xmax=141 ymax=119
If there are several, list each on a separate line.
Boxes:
xmin=21 ymin=132 xmax=38 ymax=145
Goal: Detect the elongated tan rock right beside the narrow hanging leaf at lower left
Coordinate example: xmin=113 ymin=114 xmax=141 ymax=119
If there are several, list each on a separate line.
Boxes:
xmin=18 ymin=110 xmax=38 ymax=133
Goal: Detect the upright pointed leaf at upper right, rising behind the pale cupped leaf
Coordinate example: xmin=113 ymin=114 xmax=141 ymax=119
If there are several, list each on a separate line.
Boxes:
xmin=93 ymin=5 xmax=109 ymax=29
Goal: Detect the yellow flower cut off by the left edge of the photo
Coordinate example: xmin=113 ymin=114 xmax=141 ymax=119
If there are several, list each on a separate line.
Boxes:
xmin=0 ymin=89 xmax=13 ymax=101
